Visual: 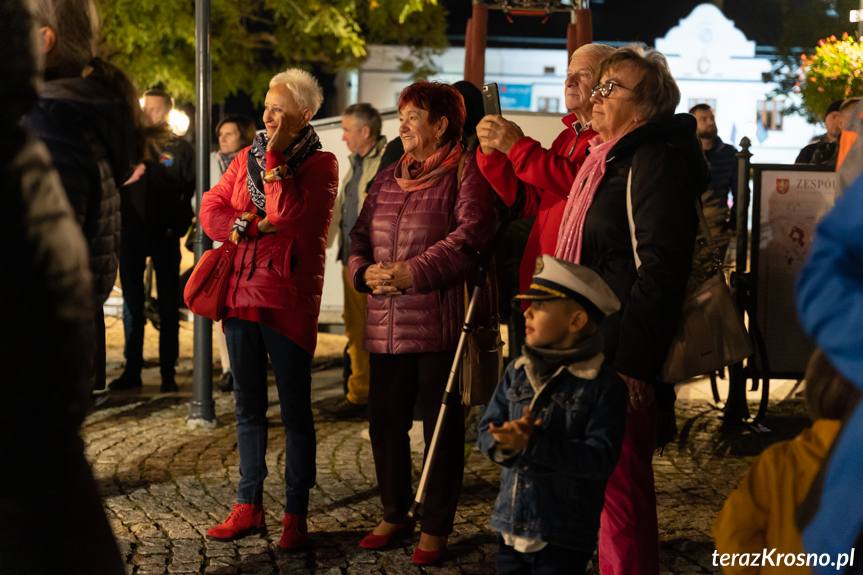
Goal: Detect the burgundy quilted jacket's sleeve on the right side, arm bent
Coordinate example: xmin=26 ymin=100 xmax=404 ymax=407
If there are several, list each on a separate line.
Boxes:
xmin=408 ymin=154 xmax=497 ymax=293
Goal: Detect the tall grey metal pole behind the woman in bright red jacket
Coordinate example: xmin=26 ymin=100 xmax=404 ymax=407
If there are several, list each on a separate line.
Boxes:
xmin=186 ymin=0 xmax=216 ymax=427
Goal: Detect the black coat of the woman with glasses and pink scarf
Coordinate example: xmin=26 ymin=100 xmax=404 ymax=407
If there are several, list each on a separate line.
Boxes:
xmin=581 ymin=114 xmax=710 ymax=381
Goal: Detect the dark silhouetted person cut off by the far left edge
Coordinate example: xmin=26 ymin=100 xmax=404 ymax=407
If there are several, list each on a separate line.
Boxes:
xmin=0 ymin=0 xmax=125 ymax=575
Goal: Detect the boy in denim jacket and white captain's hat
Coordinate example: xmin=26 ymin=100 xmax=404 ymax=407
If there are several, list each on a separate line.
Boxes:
xmin=477 ymin=255 xmax=627 ymax=574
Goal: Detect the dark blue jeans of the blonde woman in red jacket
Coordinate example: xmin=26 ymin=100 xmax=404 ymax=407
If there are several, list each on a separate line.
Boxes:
xmin=223 ymin=317 xmax=315 ymax=515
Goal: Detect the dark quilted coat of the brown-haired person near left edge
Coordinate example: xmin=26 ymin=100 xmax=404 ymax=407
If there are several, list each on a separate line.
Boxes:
xmin=24 ymin=76 xmax=136 ymax=305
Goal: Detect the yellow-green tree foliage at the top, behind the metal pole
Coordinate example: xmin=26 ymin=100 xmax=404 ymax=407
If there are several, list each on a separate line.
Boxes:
xmin=96 ymin=0 xmax=447 ymax=103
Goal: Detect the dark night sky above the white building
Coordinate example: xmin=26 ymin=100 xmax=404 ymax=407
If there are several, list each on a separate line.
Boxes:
xmin=440 ymin=0 xmax=781 ymax=47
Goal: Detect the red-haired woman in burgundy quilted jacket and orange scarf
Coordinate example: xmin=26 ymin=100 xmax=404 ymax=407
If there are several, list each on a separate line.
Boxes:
xmin=348 ymin=81 xmax=495 ymax=564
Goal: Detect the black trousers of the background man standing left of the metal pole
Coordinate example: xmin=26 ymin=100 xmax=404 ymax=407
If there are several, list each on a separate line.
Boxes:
xmin=120 ymin=232 xmax=180 ymax=379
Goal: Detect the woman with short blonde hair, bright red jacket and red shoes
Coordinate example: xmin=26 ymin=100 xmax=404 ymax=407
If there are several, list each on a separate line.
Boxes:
xmin=200 ymin=69 xmax=338 ymax=549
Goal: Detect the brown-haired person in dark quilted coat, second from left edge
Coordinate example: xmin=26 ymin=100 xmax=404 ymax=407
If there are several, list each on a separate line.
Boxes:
xmin=23 ymin=0 xmax=154 ymax=404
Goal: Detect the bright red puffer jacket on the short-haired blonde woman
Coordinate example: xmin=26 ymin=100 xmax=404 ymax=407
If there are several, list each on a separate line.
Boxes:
xmin=200 ymin=147 xmax=339 ymax=316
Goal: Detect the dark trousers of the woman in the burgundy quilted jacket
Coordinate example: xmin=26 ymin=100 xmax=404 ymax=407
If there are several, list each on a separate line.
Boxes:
xmin=369 ymin=352 xmax=464 ymax=536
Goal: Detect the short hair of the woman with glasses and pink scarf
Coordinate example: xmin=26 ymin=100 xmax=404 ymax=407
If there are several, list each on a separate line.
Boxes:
xmin=599 ymin=44 xmax=680 ymax=122
